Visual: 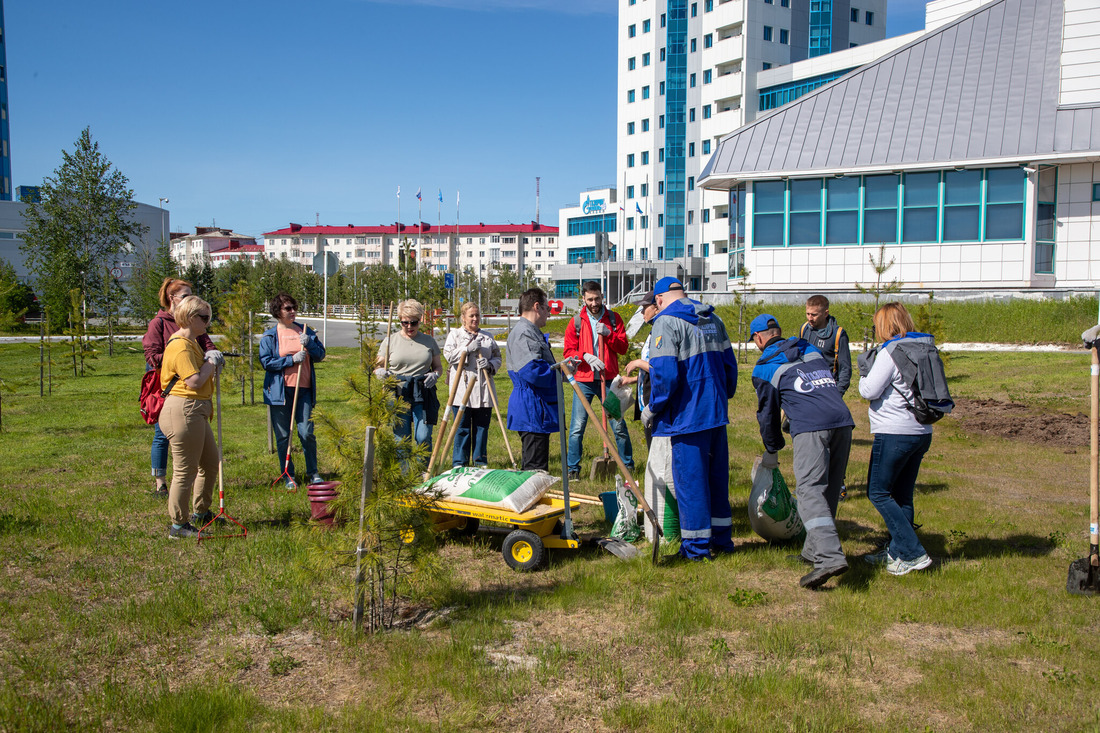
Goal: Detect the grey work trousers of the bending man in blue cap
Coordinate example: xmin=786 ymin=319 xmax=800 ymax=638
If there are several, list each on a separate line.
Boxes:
xmin=793 ymin=427 xmax=851 ymax=568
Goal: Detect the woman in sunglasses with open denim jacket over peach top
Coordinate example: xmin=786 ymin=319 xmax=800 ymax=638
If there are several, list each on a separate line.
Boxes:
xmin=260 ymin=293 xmax=325 ymax=491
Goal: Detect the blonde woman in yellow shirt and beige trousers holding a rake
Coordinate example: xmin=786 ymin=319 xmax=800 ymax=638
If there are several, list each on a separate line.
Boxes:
xmin=160 ymin=295 xmax=219 ymax=539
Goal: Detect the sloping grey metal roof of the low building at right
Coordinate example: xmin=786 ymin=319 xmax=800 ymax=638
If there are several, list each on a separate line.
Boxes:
xmin=700 ymin=0 xmax=1100 ymax=188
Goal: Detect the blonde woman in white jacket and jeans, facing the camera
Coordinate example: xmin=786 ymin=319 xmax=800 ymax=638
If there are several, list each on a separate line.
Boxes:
xmin=443 ymin=302 xmax=501 ymax=468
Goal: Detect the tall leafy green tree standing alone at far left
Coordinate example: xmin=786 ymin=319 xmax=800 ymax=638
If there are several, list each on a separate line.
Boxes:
xmin=21 ymin=128 xmax=145 ymax=327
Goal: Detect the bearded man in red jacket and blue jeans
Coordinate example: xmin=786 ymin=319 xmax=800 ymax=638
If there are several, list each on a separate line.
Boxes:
xmin=565 ymin=281 xmax=634 ymax=479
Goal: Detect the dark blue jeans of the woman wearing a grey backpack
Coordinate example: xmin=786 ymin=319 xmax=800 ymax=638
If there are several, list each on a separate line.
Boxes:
xmin=867 ymin=433 xmax=932 ymax=560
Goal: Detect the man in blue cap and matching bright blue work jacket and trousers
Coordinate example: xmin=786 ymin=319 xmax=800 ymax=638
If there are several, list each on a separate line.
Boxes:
xmin=641 ymin=277 xmax=737 ymax=560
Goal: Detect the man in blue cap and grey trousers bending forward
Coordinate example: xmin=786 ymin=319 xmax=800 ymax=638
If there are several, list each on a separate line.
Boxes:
xmin=749 ymin=314 xmax=855 ymax=589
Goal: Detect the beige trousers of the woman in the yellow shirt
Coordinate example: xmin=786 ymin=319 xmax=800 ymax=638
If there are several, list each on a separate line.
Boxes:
xmin=161 ymin=395 xmax=219 ymax=524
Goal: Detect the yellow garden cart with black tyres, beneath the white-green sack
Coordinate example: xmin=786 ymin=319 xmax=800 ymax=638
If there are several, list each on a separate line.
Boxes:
xmin=407 ymin=496 xmax=581 ymax=571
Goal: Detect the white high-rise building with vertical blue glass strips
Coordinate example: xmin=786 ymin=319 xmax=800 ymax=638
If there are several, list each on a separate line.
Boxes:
xmin=615 ymin=0 xmax=886 ymax=291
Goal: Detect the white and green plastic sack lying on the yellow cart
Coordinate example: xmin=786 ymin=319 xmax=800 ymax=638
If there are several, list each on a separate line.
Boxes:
xmin=421 ymin=467 xmax=561 ymax=514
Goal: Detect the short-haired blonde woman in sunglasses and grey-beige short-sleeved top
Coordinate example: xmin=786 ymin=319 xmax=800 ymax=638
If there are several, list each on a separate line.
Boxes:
xmin=374 ymin=298 xmax=443 ymax=450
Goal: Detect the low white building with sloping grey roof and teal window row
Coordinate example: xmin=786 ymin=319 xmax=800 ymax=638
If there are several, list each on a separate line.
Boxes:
xmin=701 ymin=0 xmax=1100 ymax=294
